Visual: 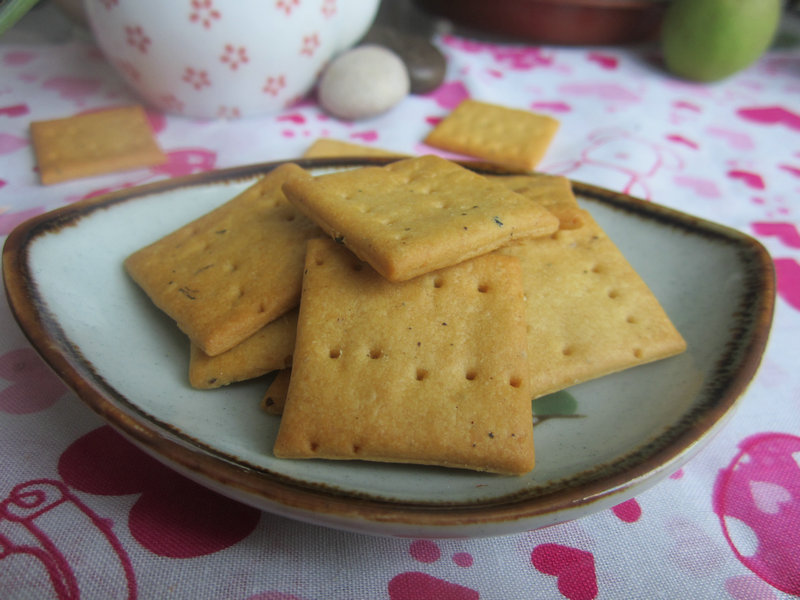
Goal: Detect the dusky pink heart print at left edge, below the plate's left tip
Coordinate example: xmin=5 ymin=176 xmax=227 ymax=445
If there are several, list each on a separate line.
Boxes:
xmin=0 ymin=348 xmax=67 ymax=415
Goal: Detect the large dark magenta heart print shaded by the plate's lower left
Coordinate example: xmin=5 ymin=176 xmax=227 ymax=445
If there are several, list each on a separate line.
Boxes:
xmin=58 ymin=426 xmax=260 ymax=558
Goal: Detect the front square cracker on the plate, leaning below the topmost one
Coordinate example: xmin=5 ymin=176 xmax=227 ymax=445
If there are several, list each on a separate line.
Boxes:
xmin=274 ymin=239 xmax=534 ymax=474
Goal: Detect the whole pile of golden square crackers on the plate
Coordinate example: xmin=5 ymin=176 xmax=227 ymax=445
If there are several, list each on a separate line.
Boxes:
xmin=125 ymin=103 xmax=685 ymax=474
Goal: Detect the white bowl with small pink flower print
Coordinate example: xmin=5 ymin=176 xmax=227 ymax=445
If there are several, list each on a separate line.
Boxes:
xmin=84 ymin=0 xmax=380 ymax=118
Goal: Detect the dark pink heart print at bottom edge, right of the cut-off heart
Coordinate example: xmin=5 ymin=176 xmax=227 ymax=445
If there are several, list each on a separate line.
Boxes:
xmin=531 ymin=544 xmax=598 ymax=600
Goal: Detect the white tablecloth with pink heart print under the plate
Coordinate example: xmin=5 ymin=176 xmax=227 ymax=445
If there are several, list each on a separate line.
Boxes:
xmin=0 ymin=2 xmax=800 ymax=600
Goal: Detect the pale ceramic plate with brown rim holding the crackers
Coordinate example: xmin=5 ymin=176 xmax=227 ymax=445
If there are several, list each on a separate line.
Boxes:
xmin=3 ymin=159 xmax=774 ymax=537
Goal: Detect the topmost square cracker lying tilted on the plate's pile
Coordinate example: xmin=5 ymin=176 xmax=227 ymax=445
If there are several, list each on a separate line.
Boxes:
xmin=283 ymin=156 xmax=558 ymax=282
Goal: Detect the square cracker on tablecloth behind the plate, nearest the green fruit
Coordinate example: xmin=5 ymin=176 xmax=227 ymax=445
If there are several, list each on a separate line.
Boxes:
xmin=425 ymin=99 xmax=559 ymax=171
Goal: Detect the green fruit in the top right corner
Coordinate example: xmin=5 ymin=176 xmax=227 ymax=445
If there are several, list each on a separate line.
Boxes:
xmin=661 ymin=0 xmax=782 ymax=81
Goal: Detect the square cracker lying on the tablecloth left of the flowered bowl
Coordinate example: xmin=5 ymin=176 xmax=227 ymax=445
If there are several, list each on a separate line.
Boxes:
xmin=31 ymin=106 xmax=167 ymax=185
